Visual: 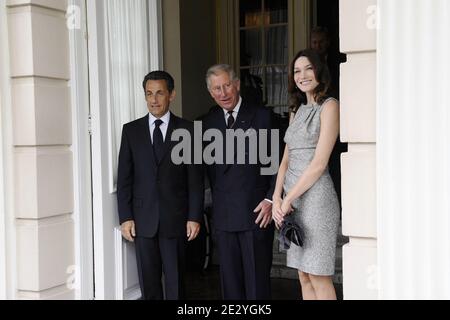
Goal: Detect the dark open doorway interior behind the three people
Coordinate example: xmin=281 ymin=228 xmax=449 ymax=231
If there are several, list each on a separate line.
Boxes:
xmin=181 ymin=0 xmax=347 ymax=299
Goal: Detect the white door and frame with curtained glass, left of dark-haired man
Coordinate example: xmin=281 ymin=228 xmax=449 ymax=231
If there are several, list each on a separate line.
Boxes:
xmin=71 ymin=0 xmax=162 ymax=300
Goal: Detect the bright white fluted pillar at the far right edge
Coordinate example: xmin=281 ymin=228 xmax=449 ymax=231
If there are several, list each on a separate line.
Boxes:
xmin=377 ymin=0 xmax=450 ymax=299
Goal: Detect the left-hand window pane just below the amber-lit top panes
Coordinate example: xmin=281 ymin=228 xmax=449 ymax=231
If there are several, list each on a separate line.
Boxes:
xmin=240 ymin=29 xmax=262 ymax=67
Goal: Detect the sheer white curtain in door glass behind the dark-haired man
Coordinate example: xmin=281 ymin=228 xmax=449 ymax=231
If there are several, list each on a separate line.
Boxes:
xmin=105 ymin=0 xmax=150 ymax=189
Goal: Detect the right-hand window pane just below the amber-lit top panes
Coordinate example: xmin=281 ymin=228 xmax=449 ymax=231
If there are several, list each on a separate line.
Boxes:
xmin=265 ymin=26 xmax=288 ymax=64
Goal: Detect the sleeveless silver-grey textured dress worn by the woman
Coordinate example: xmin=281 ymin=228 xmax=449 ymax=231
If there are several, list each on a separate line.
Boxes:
xmin=284 ymin=97 xmax=340 ymax=276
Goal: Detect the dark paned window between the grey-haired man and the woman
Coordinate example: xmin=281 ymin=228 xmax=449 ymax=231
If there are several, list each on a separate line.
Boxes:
xmin=239 ymin=0 xmax=289 ymax=115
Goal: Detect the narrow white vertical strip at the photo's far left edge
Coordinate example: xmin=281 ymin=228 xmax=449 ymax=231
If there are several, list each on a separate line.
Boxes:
xmin=0 ymin=0 xmax=17 ymax=299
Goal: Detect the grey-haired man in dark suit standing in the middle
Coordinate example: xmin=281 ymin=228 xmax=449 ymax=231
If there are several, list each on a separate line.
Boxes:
xmin=203 ymin=65 xmax=277 ymax=300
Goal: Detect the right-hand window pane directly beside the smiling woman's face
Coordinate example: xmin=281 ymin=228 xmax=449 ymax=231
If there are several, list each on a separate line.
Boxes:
xmin=266 ymin=67 xmax=288 ymax=106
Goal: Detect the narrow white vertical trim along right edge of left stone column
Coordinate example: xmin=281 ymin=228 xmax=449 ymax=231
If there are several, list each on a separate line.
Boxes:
xmin=68 ymin=0 xmax=94 ymax=300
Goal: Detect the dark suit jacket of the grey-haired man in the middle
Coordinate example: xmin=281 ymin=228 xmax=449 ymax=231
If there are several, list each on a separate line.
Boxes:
xmin=203 ymin=100 xmax=278 ymax=232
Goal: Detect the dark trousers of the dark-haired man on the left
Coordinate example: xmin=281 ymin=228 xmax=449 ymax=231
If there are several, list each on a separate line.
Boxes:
xmin=135 ymin=237 xmax=186 ymax=300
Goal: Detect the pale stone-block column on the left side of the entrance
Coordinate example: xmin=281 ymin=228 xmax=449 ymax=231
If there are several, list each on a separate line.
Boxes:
xmin=7 ymin=0 xmax=74 ymax=299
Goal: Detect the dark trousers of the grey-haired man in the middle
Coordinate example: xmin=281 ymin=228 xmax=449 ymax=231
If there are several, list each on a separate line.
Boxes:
xmin=217 ymin=224 xmax=274 ymax=300
